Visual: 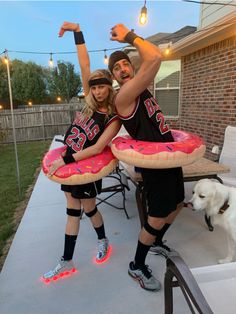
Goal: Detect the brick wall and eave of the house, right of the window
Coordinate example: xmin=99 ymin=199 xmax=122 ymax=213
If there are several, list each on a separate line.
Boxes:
xmin=170 ymin=10 xmax=236 ymax=159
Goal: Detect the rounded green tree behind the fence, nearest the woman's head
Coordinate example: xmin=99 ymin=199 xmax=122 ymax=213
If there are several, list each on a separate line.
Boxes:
xmin=48 ymin=61 xmax=82 ymax=103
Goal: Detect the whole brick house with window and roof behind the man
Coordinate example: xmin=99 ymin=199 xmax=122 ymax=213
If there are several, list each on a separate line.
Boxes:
xmin=125 ymin=4 xmax=236 ymax=159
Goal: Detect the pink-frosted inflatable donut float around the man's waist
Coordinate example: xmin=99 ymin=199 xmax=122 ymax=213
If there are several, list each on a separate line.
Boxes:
xmin=111 ymin=130 xmax=206 ymax=169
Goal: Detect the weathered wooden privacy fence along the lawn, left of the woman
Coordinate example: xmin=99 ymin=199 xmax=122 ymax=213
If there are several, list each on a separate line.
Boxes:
xmin=0 ymin=103 xmax=83 ymax=143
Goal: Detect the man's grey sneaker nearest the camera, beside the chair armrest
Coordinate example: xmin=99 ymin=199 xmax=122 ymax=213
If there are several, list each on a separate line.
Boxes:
xmin=128 ymin=262 xmax=161 ymax=291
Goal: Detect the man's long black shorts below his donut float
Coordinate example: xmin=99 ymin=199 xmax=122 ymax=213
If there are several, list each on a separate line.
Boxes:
xmin=140 ymin=168 xmax=184 ymax=218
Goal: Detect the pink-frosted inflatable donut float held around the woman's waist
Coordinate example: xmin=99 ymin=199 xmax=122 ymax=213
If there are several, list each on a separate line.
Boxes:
xmin=42 ymin=145 xmax=118 ymax=185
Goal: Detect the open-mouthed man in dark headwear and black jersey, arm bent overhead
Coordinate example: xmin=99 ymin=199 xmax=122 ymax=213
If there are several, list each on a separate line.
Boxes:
xmin=108 ymin=24 xmax=184 ymax=291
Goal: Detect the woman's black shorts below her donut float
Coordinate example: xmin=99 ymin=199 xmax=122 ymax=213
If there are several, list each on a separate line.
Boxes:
xmin=61 ymin=180 xmax=102 ymax=199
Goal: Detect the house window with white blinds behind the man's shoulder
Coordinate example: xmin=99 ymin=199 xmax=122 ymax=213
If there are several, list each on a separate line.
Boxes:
xmin=154 ymin=60 xmax=181 ymax=117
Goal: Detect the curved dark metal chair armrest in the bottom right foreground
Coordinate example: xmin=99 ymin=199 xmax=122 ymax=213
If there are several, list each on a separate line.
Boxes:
xmin=164 ymin=251 xmax=213 ymax=314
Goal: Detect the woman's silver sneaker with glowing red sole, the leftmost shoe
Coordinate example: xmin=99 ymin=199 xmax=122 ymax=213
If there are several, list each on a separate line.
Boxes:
xmin=42 ymin=258 xmax=77 ymax=283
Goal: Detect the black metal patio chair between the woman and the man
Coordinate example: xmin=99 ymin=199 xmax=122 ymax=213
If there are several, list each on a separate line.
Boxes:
xmin=97 ymin=165 xmax=130 ymax=219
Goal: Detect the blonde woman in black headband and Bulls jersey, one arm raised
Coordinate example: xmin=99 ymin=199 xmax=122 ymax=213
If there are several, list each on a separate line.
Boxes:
xmin=43 ymin=22 xmax=120 ymax=281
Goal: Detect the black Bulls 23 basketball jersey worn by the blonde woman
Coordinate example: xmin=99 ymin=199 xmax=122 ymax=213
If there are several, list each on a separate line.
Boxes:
xmin=64 ymin=111 xmax=118 ymax=154
